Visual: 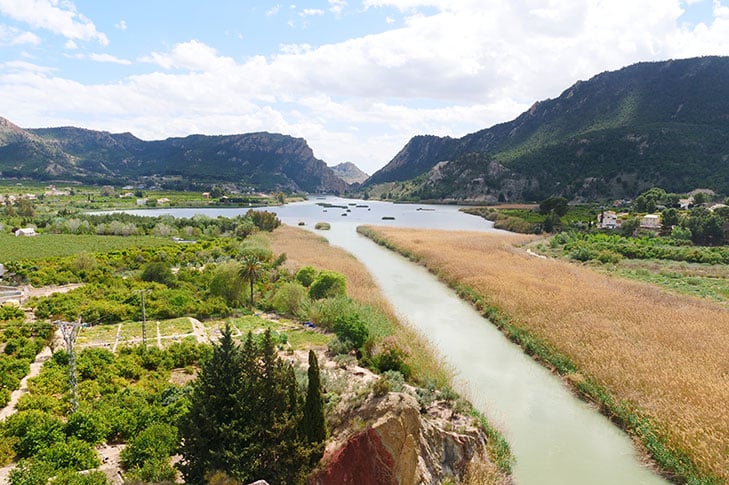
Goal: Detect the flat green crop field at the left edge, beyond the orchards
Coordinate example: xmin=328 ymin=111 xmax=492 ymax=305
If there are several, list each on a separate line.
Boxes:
xmin=0 ymin=234 xmax=172 ymax=263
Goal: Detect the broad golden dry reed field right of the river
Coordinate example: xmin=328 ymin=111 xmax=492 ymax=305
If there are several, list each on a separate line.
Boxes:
xmin=362 ymin=227 xmax=729 ymax=483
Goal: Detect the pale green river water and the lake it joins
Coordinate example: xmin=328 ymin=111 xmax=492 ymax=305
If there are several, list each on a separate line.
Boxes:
xmin=123 ymin=198 xmax=666 ymax=485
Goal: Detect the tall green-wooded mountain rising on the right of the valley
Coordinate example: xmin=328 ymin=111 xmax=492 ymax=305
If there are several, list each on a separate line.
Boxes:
xmin=365 ymin=57 xmax=729 ymax=201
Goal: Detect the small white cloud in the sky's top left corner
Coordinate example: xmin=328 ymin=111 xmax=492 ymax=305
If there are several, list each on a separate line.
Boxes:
xmin=0 ymin=0 xmax=109 ymax=46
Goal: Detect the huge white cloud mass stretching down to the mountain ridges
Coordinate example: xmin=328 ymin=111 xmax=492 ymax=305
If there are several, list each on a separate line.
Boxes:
xmin=0 ymin=0 xmax=729 ymax=173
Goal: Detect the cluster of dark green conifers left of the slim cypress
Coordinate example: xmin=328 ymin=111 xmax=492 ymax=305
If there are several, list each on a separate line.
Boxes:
xmin=179 ymin=325 xmax=318 ymax=483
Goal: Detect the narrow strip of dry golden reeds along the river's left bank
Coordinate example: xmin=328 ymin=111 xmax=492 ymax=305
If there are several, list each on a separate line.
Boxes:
xmin=268 ymin=226 xmax=513 ymax=473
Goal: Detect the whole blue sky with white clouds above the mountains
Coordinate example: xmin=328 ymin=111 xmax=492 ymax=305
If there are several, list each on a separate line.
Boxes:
xmin=0 ymin=0 xmax=729 ymax=174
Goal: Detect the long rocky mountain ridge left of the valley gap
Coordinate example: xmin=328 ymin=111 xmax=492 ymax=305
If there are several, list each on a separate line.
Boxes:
xmin=0 ymin=118 xmax=347 ymax=193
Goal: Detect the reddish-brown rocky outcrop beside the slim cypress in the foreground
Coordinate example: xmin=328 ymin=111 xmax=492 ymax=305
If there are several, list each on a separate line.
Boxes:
xmin=312 ymin=392 xmax=488 ymax=485
